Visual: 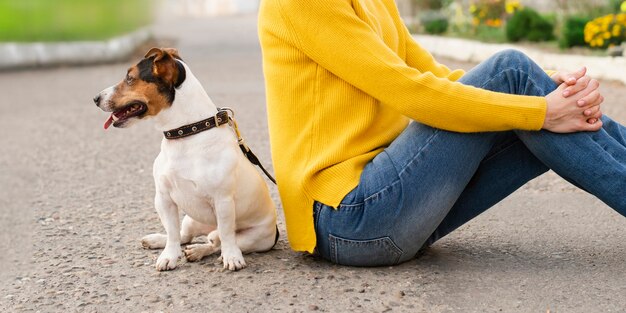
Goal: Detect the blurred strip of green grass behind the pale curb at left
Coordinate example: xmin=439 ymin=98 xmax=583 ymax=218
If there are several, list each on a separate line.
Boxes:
xmin=0 ymin=0 xmax=157 ymax=42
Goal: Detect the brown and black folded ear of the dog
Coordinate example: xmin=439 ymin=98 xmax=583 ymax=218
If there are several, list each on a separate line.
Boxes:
xmin=145 ymin=48 xmax=185 ymax=87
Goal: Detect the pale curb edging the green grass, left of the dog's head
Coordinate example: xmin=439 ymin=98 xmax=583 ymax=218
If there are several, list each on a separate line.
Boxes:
xmin=0 ymin=28 xmax=152 ymax=70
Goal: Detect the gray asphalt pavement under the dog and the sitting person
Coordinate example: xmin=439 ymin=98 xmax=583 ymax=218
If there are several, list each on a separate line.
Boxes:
xmin=0 ymin=16 xmax=626 ymax=312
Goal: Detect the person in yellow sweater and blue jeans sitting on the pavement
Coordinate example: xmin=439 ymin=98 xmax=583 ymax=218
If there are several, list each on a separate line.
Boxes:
xmin=259 ymin=0 xmax=626 ymax=266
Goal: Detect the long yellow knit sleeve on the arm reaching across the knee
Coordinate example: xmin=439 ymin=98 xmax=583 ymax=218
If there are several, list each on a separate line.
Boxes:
xmin=276 ymin=0 xmax=546 ymax=132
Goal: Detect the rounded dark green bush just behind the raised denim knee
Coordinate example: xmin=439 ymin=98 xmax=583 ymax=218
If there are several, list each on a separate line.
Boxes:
xmin=506 ymin=8 xmax=554 ymax=42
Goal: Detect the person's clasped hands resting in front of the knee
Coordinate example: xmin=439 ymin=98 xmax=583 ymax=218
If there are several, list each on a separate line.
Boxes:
xmin=543 ymin=76 xmax=604 ymax=133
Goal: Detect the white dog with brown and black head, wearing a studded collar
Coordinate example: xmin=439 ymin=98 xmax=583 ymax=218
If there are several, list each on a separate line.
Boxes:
xmin=94 ymin=48 xmax=278 ymax=271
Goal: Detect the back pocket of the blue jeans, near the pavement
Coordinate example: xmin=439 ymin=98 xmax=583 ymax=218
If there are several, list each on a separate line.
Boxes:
xmin=329 ymin=235 xmax=402 ymax=266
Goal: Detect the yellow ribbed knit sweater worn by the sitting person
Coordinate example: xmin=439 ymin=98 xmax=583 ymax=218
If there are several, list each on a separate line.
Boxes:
xmin=259 ymin=0 xmax=546 ymax=252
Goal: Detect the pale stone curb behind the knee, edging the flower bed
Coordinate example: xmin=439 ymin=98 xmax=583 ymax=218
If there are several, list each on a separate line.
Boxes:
xmin=413 ymin=35 xmax=626 ymax=84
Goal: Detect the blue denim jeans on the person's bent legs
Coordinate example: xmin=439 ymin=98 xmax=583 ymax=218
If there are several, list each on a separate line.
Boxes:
xmin=313 ymin=50 xmax=626 ymax=266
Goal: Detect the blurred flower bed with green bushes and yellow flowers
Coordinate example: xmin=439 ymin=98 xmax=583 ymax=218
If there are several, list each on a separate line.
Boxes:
xmin=398 ymin=0 xmax=626 ymax=55
